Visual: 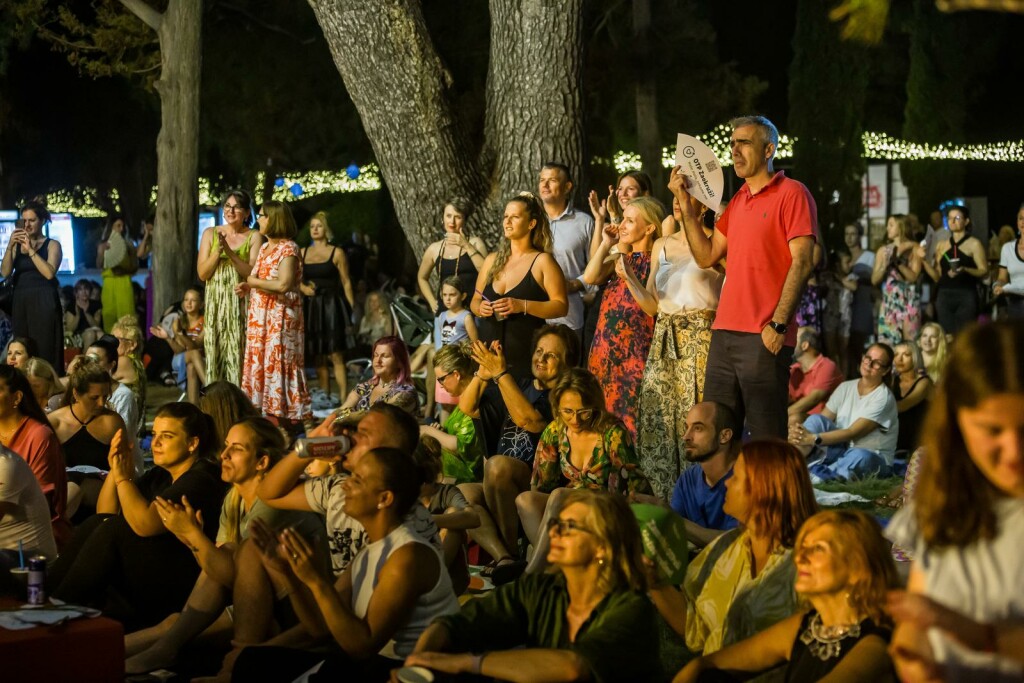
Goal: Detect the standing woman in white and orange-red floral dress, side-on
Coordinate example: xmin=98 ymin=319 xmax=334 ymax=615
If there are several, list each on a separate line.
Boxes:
xmin=234 ymin=202 xmax=310 ymax=423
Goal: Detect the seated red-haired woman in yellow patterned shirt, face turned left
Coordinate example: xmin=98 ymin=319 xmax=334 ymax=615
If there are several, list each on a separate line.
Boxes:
xmin=650 ymin=440 xmax=817 ymax=654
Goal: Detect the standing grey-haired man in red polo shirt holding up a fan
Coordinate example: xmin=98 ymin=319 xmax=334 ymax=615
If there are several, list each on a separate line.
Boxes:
xmin=669 ymin=116 xmax=818 ymax=438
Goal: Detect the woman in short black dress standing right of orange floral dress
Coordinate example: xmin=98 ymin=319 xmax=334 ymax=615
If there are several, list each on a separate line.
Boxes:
xmin=299 ymin=211 xmax=355 ymax=397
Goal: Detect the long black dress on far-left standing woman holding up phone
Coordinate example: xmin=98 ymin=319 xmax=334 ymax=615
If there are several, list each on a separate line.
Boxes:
xmin=11 ymin=239 xmax=63 ymax=375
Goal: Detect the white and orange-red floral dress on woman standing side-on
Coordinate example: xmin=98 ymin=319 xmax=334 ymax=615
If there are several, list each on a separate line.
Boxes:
xmin=242 ymin=240 xmax=310 ymax=420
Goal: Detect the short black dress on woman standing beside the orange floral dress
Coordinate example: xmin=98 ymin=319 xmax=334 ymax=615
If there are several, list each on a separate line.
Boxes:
xmin=302 ymin=248 xmax=355 ymax=359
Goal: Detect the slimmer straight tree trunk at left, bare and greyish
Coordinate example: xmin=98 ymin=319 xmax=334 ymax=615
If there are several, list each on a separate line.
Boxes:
xmin=121 ymin=0 xmax=203 ymax=311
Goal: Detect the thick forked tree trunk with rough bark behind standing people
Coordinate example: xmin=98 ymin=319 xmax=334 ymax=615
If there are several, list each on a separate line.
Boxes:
xmin=309 ymin=0 xmax=583 ymax=257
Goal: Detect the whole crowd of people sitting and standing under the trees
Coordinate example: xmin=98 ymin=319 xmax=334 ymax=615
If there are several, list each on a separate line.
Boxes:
xmin=0 ymin=117 xmax=1024 ymax=681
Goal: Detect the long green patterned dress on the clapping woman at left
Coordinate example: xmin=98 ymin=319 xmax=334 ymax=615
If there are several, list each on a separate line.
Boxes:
xmin=203 ymin=230 xmax=256 ymax=385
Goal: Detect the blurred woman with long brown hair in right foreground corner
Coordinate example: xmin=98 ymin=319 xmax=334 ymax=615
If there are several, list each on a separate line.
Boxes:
xmin=886 ymin=322 xmax=1024 ymax=681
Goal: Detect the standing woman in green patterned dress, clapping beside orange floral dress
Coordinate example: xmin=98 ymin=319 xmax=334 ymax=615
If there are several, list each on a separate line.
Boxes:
xmin=197 ymin=189 xmax=263 ymax=384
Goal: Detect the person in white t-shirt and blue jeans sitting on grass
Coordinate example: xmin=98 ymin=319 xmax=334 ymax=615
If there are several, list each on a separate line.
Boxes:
xmin=790 ymin=344 xmax=899 ymax=480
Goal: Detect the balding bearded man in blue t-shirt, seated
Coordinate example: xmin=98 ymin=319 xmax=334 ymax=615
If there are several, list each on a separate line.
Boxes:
xmin=672 ymin=401 xmax=740 ymax=547
